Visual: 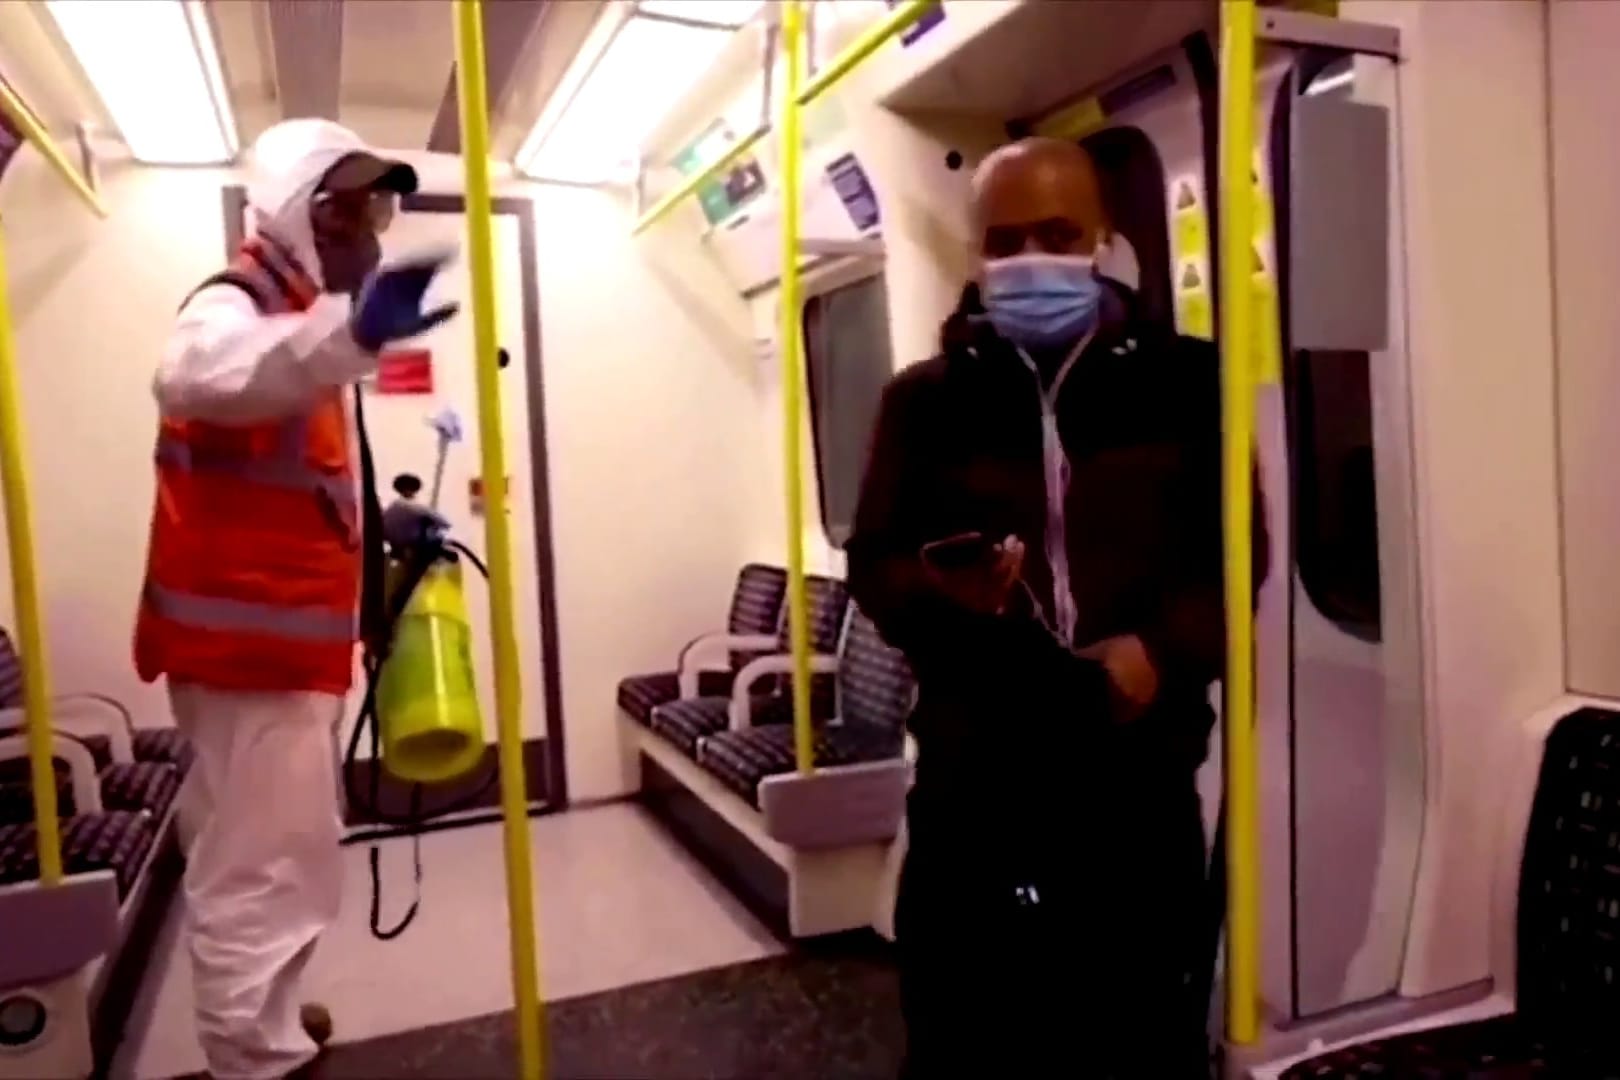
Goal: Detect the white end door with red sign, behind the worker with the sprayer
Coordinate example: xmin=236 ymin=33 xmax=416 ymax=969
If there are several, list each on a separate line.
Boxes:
xmin=351 ymin=196 xmax=561 ymax=810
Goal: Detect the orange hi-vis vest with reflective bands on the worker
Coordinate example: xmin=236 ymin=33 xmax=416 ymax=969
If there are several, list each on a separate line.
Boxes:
xmin=134 ymin=240 xmax=361 ymax=695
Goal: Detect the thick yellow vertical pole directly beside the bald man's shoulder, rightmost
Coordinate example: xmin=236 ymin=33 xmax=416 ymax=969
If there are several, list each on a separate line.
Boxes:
xmin=1220 ymin=0 xmax=1260 ymax=1044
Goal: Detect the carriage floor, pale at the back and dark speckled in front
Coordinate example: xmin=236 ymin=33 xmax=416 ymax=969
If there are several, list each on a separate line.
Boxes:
xmin=110 ymin=803 xmax=902 ymax=1080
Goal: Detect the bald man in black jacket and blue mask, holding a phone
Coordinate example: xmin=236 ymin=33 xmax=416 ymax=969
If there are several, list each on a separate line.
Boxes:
xmin=847 ymin=139 xmax=1265 ymax=1080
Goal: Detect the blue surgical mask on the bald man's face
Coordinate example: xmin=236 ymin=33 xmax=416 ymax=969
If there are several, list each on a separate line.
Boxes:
xmin=980 ymin=253 xmax=1103 ymax=348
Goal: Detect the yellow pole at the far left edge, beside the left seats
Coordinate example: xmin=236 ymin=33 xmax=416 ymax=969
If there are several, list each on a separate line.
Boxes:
xmin=0 ymin=223 xmax=62 ymax=886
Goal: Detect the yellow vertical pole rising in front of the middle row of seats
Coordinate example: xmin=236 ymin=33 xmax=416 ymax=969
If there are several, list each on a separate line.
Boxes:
xmin=776 ymin=0 xmax=815 ymax=772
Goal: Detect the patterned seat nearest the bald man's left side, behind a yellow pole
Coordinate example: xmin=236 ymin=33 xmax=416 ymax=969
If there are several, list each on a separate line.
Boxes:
xmin=698 ymin=610 xmax=915 ymax=806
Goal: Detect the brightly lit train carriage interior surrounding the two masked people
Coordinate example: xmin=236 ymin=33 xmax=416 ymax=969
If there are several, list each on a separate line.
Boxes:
xmin=0 ymin=0 xmax=1620 ymax=1080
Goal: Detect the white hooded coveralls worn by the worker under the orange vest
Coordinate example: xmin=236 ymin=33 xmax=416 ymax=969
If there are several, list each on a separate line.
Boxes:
xmin=154 ymin=120 xmax=388 ymax=1080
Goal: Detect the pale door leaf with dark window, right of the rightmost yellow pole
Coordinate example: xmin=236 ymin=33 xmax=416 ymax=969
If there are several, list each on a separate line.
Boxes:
xmin=1252 ymin=49 xmax=1424 ymax=1018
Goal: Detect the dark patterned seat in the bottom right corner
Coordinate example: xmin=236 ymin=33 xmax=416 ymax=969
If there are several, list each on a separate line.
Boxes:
xmin=1283 ymin=709 xmax=1620 ymax=1080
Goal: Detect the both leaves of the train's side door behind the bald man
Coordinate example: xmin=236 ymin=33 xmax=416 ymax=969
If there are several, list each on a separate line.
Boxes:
xmin=1069 ymin=27 xmax=1422 ymax=1018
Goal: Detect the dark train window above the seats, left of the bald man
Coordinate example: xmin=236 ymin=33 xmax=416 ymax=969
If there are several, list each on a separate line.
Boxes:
xmin=804 ymin=274 xmax=894 ymax=547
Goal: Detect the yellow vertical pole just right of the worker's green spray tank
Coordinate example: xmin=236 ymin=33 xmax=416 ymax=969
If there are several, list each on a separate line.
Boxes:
xmin=455 ymin=0 xmax=544 ymax=1080
